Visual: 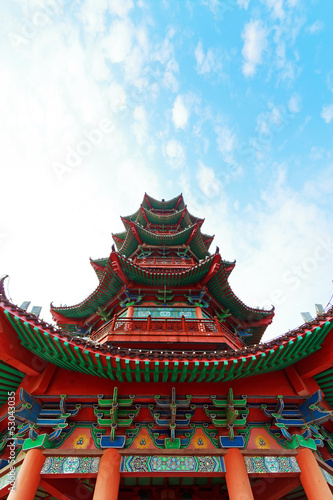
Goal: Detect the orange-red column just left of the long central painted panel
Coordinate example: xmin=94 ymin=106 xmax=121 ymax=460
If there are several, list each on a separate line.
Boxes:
xmin=93 ymin=448 xmax=120 ymax=500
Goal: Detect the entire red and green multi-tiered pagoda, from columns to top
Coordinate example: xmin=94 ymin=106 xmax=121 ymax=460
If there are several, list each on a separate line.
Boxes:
xmin=0 ymin=194 xmax=333 ymax=500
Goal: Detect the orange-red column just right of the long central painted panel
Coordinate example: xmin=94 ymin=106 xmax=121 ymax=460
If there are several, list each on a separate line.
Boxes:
xmin=224 ymin=448 xmax=253 ymax=500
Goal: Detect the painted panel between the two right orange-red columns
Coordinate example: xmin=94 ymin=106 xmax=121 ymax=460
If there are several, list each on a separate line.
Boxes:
xmin=244 ymin=456 xmax=301 ymax=474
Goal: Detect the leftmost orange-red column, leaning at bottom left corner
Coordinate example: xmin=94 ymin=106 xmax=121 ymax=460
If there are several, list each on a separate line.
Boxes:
xmin=8 ymin=449 xmax=45 ymax=500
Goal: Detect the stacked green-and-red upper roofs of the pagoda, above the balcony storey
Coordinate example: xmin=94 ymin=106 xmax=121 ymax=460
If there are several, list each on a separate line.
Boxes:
xmin=51 ymin=195 xmax=274 ymax=344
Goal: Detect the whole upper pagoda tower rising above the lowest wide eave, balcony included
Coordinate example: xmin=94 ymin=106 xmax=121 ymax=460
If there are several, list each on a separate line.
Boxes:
xmin=51 ymin=193 xmax=274 ymax=349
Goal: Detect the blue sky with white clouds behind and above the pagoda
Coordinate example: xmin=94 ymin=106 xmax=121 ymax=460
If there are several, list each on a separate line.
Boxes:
xmin=0 ymin=0 xmax=333 ymax=336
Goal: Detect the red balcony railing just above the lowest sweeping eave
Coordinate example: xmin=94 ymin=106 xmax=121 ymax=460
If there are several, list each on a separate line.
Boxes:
xmin=91 ymin=315 xmax=245 ymax=349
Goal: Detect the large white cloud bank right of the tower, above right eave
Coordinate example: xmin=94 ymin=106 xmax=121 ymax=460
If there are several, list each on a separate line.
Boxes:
xmin=215 ymin=165 xmax=333 ymax=338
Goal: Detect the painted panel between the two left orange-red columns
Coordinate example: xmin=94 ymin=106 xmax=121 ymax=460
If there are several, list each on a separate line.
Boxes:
xmin=41 ymin=457 xmax=100 ymax=474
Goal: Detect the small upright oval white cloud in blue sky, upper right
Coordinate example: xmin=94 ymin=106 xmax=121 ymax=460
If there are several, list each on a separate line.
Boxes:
xmin=242 ymin=20 xmax=267 ymax=76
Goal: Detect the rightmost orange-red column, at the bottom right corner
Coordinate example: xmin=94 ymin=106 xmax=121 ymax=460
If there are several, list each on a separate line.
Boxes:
xmin=297 ymin=448 xmax=333 ymax=500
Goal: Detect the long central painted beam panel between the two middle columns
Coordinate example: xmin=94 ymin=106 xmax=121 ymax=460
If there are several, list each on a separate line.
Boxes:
xmin=120 ymin=455 xmax=225 ymax=473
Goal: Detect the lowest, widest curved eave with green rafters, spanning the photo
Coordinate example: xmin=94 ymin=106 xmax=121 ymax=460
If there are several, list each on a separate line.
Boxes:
xmin=0 ymin=297 xmax=333 ymax=382
